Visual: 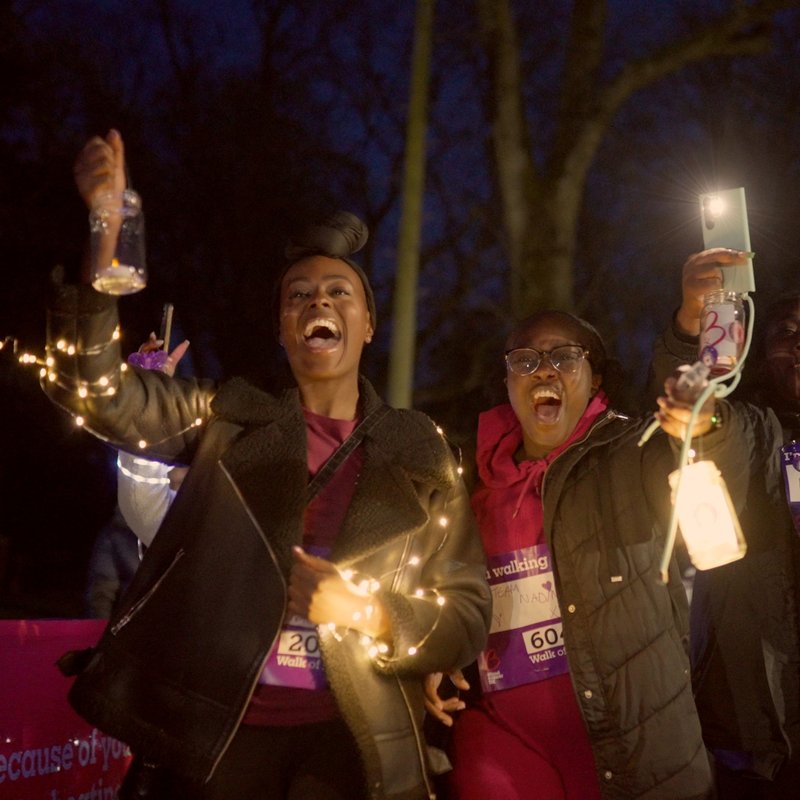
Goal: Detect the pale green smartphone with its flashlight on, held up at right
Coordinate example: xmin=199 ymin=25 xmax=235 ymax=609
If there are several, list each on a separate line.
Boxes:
xmin=700 ymin=187 xmax=756 ymax=294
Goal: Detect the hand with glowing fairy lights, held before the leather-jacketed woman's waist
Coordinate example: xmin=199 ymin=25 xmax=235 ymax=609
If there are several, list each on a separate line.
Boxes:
xmin=288 ymin=547 xmax=391 ymax=639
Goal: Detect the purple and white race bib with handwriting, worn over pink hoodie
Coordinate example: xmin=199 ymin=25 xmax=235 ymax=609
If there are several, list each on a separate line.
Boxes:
xmin=478 ymin=544 xmax=569 ymax=692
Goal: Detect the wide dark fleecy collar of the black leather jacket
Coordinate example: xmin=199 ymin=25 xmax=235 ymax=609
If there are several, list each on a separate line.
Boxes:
xmin=212 ymin=378 xmax=457 ymax=572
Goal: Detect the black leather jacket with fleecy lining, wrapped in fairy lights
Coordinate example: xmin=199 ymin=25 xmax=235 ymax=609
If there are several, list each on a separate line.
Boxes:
xmin=44 ymin=292 xmax=491 ymax=800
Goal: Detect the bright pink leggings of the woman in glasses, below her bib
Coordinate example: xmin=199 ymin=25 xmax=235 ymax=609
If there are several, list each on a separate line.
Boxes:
xmin=448 ymin=707 xmax=600 ymax=800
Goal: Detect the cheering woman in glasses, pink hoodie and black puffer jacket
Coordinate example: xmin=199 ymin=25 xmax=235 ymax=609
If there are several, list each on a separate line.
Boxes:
xmin=440 ymin=311 xmax=764 ymax=800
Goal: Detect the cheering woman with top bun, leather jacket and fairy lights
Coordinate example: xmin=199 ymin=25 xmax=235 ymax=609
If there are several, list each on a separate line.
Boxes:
xmin=50 ymin=133 xmax=491 ymax=800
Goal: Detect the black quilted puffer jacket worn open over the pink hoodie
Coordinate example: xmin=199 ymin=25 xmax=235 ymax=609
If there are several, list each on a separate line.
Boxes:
xmin=542 ymin=411 xmax=720 ymax=800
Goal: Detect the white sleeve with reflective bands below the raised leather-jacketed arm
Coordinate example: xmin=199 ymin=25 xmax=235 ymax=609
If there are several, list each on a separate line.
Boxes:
xmin=117 ymin=450 xmax=175 ymax=546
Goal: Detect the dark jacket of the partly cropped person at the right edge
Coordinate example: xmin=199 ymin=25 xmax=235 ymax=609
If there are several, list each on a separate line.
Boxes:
xmin=649 ymin=320 xmax=800 ymax=778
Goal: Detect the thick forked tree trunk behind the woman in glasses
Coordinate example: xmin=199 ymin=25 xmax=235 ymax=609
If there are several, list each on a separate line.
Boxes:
xmin=477 ymin=0 xmax=797 ymax=319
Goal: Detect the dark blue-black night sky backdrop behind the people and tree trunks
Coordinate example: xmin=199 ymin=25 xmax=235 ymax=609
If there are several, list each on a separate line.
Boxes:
xmin=0 ymin=0 xmax=800 ymax=617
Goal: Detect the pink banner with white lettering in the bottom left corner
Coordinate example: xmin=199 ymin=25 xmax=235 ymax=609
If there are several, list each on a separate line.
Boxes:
xmin=0 ymin=620 xmax=131 ymax=800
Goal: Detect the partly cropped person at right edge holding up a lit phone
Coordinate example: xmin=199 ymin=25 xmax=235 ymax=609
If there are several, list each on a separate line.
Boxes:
xmin=650 ymin=248 xmax=800 ymax=800
